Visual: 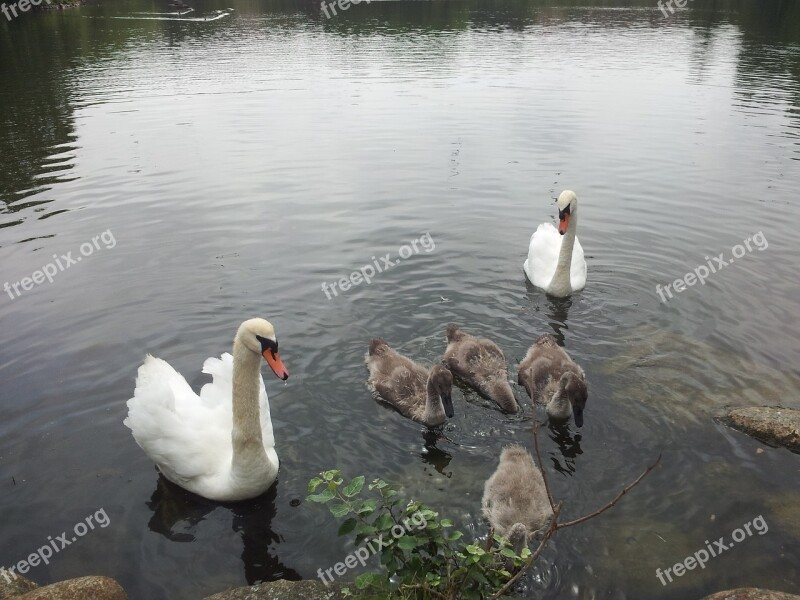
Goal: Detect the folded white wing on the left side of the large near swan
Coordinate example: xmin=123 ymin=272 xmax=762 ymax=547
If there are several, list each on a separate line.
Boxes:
xmin=124 ymin=356 xmax=231 ymax=483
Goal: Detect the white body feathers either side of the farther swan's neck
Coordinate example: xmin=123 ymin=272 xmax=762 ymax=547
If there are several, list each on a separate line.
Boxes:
xmin=522 ymin=223 xmax=586 ymax=291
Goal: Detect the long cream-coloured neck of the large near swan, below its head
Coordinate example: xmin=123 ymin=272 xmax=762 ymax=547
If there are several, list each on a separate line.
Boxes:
xmin=231 ymin=338 xmax=266 ymax=476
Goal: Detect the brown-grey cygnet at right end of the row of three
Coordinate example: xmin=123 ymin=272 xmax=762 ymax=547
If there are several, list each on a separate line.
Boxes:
xmin=517 ymin=334 xmax=588 ymax=427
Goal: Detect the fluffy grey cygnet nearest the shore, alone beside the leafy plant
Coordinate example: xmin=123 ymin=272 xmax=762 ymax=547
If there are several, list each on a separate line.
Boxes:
xmin=481 ymin=445 xmax=553 ymax=553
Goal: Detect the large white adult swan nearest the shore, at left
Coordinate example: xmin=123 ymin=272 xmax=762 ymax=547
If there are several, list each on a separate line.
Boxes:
xmin=124 ymin=319 xmax=289 ymax=502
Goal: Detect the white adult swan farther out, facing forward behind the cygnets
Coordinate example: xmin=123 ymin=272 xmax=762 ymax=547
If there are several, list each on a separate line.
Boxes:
xmin=522 ymin=190 xmax=586 ymax=298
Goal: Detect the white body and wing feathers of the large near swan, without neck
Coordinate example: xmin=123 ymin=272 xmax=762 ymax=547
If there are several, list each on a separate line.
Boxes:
xmin=124 ymin=352 xmax=278 ymax=501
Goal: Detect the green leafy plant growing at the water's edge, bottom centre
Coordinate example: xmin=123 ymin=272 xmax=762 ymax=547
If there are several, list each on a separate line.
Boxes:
xmin=307 ymin=470 xmax=531 ymax=600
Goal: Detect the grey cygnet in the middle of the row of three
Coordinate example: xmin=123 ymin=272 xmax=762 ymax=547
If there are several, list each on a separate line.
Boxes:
xmin=442 ymin=325 xmax=519 ymax=414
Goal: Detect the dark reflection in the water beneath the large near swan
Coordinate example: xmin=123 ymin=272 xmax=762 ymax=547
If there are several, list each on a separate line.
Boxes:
xmin=147 ymin=476 xmax=301 ymax=585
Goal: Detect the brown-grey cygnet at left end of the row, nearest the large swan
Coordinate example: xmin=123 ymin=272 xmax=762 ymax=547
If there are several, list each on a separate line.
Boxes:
xmin=365 ymin=338 xmax=454 ymax=427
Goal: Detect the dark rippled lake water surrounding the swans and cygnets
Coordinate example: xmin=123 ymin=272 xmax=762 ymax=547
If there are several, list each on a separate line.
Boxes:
xmin=0 ymin=0 xmax=800 ymax=600
